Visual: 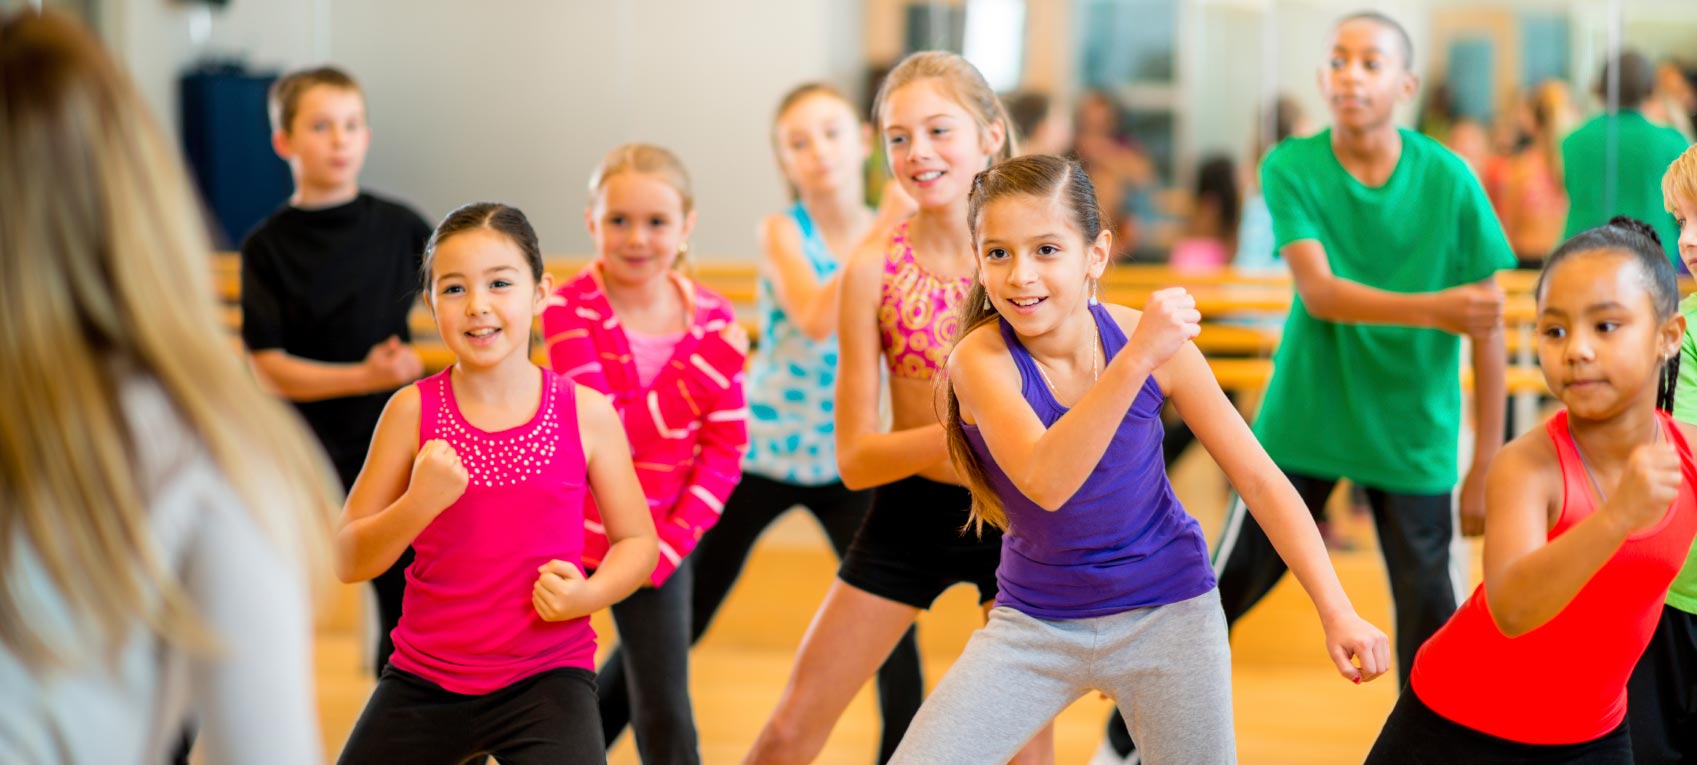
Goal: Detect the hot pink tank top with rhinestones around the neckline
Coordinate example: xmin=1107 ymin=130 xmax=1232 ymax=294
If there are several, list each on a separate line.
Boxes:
xmin=390 ymin=368 xmax=596 ymax=695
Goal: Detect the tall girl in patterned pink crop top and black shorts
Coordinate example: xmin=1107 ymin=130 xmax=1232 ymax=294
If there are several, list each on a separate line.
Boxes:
xmin=745 ymin=53 xmax=1054 ymax=763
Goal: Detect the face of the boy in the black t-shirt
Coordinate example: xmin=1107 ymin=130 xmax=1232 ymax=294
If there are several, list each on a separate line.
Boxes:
xmin=272 ymin=85 xmax=372 ymax=192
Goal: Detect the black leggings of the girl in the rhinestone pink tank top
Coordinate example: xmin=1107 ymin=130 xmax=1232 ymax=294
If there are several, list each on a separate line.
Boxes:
xmin=336 ymin=667 xmax=608 ymax=765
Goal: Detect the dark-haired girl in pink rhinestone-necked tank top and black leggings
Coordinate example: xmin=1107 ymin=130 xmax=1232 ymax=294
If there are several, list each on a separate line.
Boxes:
xmin=336 ymin=204 xmax=658 ymax=763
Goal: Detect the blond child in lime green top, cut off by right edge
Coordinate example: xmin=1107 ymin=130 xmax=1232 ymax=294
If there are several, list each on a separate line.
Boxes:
xmin=1626 ymin=148 xmax=1697 ymax=762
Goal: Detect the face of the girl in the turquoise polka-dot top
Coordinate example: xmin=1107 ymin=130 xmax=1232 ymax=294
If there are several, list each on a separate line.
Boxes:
xmin=772 ymin=92 xmax=872 ymax=197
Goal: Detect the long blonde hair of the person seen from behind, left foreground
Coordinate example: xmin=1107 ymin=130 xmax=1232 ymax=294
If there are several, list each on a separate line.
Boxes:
xmin=0 ymin=12 xmax=334 ymax=667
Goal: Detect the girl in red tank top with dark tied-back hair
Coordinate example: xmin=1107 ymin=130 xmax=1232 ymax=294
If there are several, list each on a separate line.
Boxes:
xmin=1368 ymin=217 xmax=1697 ymax=765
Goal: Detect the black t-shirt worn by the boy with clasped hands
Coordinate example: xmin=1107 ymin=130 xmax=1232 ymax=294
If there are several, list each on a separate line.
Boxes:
xmin=241 ymin=193 xmax=431 ymax=473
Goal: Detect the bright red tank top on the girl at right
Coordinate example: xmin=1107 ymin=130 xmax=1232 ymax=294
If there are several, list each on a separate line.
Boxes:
xmin=1409 ymin=410 xmax=1697 ymax=745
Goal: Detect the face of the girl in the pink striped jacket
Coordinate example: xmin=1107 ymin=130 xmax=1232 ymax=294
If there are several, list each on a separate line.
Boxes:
xmin=585 ymin=171 xmax=696 ymax=285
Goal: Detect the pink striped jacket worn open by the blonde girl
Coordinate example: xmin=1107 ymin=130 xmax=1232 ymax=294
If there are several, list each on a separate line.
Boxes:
xmin=541 ymin=261 xmax=748 ymax=587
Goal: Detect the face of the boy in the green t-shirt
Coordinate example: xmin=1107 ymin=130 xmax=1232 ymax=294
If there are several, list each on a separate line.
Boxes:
xmin=1320 ymin=19 xmax=1417 ymax=131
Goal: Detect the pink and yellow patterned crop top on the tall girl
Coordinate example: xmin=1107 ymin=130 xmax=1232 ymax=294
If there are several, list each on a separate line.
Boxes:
xmin=877 ymin=224 xmax=972 ymax=380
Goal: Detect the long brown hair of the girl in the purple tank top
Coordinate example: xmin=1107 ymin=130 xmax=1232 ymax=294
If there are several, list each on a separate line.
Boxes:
xmin=944 ymin=154 xmax=1101 ymax=533
